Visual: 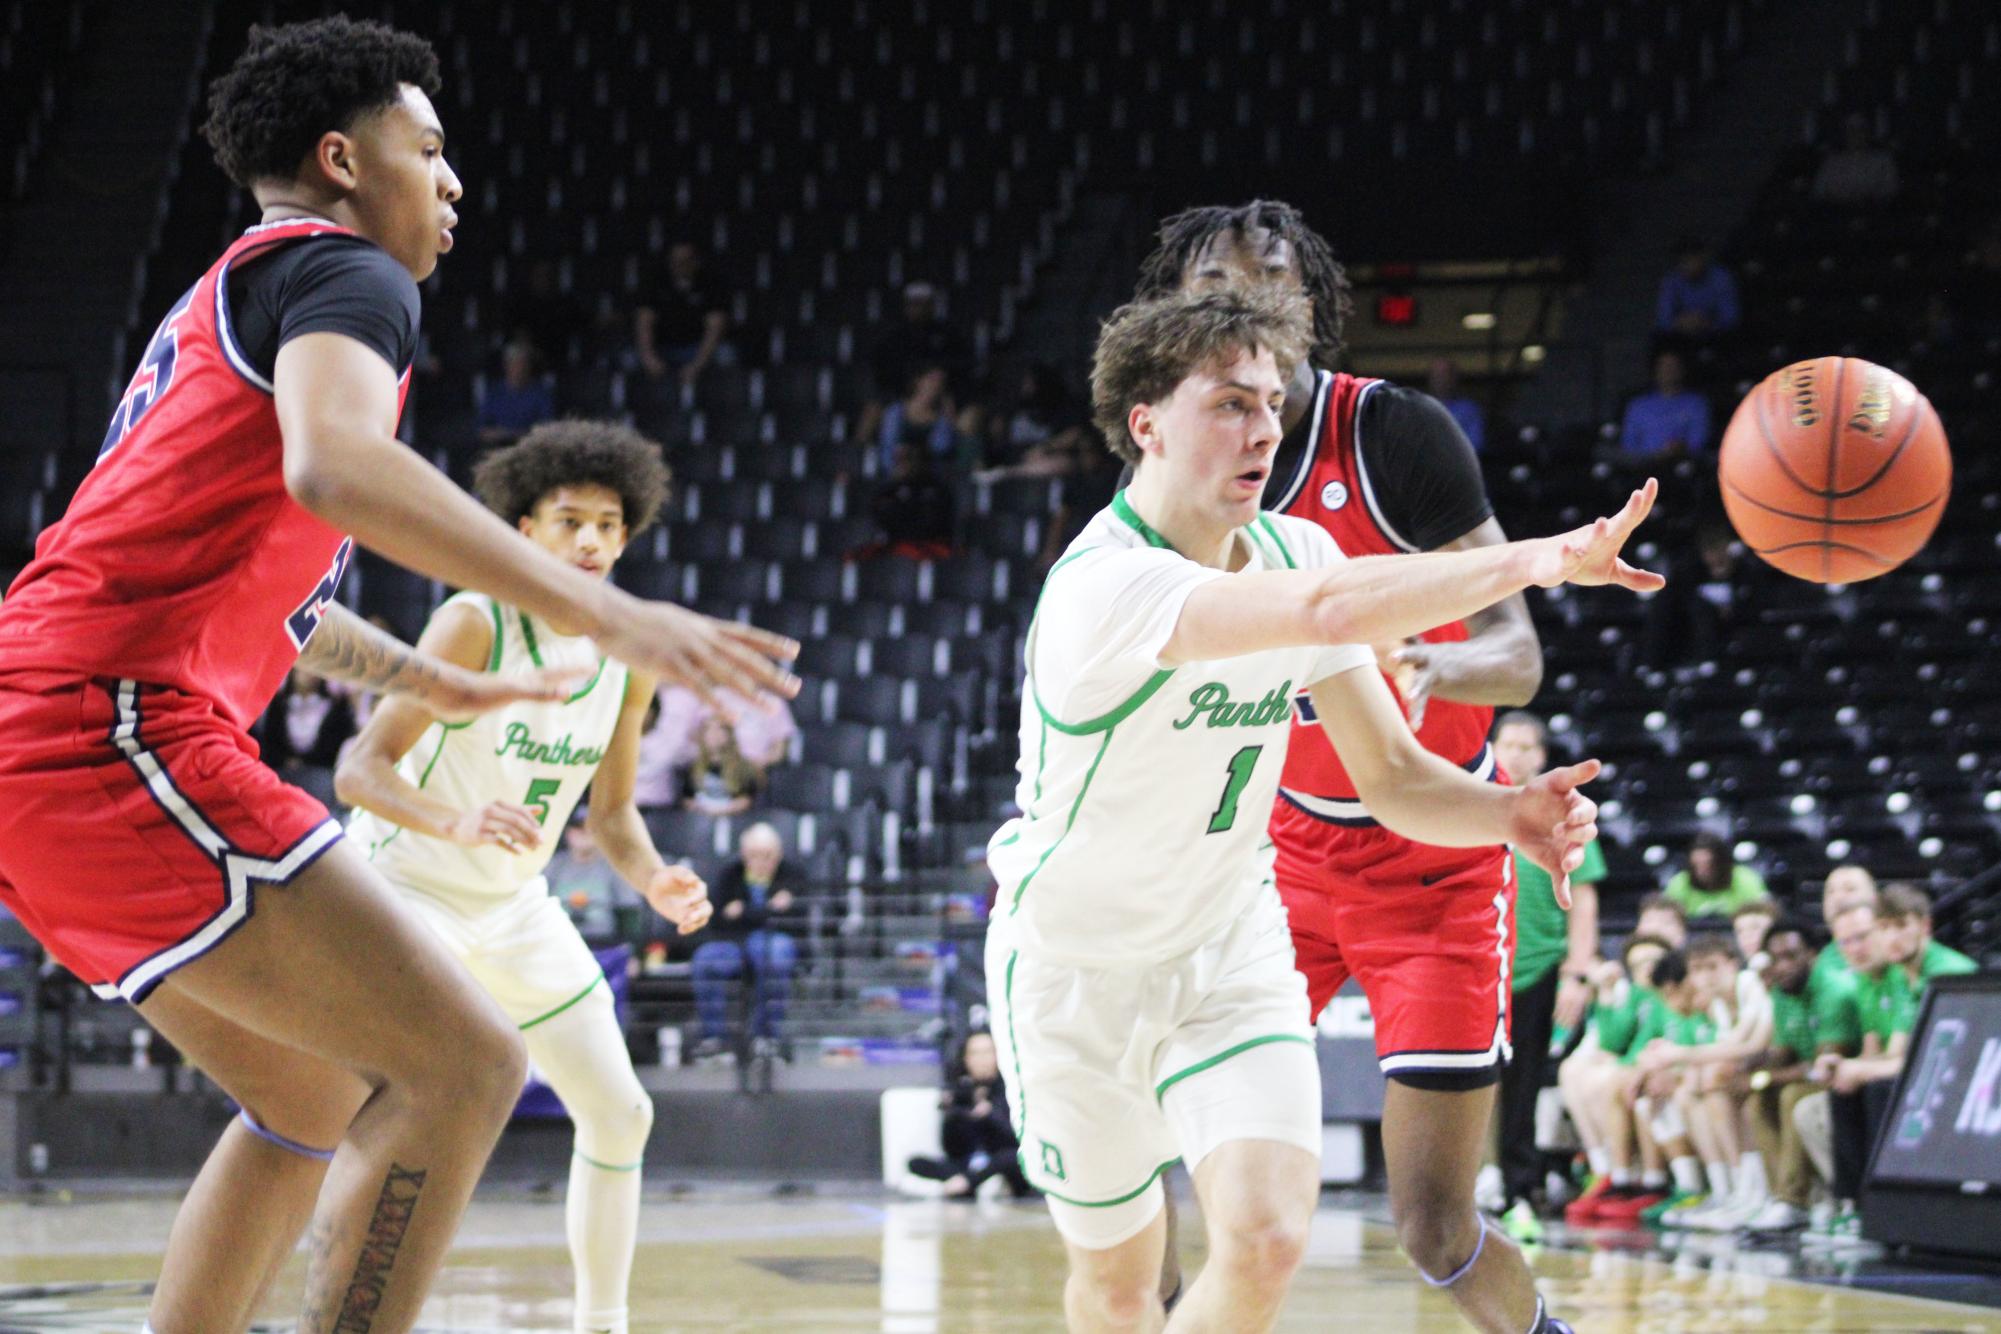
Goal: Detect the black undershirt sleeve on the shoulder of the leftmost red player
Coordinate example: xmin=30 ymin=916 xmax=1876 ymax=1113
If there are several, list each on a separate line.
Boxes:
xmin=230 ymin=236 xmax=420 ymax=380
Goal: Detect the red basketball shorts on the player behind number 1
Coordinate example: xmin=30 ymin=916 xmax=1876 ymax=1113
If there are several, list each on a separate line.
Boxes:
xmin=1271 ymin=798 xmax=1515 ymax=1088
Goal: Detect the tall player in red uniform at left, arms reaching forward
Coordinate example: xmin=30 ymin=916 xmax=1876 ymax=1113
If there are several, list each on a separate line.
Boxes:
xmin=0 ymin=18 xmax=796 ymax=1334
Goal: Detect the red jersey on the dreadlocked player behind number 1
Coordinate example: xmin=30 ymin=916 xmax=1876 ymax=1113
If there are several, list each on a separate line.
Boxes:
xmin=1277 ymin=370 xmax=1493 ymax=824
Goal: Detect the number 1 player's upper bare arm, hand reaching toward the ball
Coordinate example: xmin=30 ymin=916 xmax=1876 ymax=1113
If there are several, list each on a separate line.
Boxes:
xmin=1161 ymin=480 xmax=1667 ymax=664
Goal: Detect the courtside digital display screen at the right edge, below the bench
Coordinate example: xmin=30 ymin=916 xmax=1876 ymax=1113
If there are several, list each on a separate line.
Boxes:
xmin=1869 ymin=974 xmax=2001 ymax=1192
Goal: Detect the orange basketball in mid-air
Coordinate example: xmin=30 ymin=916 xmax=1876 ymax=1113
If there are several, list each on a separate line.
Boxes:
xmin=1719 ymin=356 xmax=1953 ymax=584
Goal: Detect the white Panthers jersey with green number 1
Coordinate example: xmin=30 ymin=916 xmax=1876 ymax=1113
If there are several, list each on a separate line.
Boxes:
xmin=986 ymin=492 xmax=1375 ymax=966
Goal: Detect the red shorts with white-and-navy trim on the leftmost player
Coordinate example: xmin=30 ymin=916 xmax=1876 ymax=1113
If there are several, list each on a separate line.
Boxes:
xmin=0 ymin=672 xmax=340 ymax=1002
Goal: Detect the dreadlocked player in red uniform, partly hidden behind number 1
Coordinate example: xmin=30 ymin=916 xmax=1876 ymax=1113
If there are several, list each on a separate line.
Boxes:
xmin=1141 ymin=200 xmax=1568 ymax=1334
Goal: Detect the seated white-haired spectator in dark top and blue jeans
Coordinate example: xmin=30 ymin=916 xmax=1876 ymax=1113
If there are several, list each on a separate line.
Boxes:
xmin=694 ymin=824 xmax=798 ymax=1060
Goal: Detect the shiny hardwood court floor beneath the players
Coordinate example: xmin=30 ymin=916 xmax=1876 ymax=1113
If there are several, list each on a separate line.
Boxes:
xmin=0 ymin=1186 xmax=2001 ymax=1334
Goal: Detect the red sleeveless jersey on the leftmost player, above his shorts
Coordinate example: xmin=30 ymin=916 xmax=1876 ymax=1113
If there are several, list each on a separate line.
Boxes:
xmin=0 ymin=220 xmax=410 ymax=728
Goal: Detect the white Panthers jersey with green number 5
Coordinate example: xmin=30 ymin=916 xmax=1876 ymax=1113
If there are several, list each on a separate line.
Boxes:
xmin=348 ymin=592 xmax=626 ymax=902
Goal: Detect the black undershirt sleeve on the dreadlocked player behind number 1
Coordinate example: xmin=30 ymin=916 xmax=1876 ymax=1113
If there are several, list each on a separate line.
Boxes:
xmin=1357 ymin=384 xmax=1495 ymax=552
